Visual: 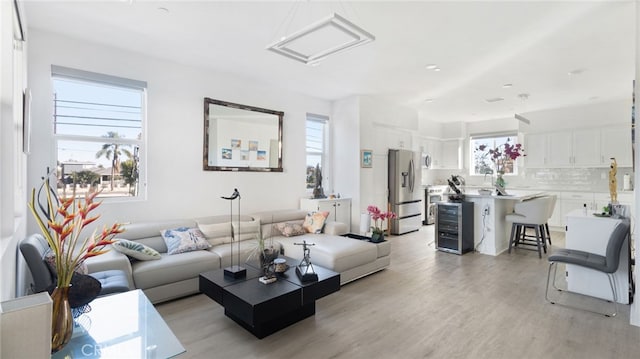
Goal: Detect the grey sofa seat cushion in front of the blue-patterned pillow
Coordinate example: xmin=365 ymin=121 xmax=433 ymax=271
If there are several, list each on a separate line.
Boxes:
xmin=132 ymin=251 xmax=220 ymax=289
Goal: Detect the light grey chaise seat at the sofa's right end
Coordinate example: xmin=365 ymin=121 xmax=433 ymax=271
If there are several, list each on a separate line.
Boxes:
xmin=275 ymin=234 xmax=378 ymax=272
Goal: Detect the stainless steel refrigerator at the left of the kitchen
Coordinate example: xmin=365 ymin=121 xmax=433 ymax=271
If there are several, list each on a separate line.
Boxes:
xmin=388 ymin=149 xmax=422 ymax=234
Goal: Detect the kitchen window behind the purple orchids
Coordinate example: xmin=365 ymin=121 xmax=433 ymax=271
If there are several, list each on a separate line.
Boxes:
xmin=469 ymin=133 xmax=518 ymax=175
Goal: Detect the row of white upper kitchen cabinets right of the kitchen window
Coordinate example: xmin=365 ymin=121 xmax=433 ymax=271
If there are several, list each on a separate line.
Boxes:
xmin=525 ymin=127 xmax=631 ymax=168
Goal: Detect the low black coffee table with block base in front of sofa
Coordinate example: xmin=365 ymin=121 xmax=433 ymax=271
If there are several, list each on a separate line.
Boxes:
xmin=200 ymin=257 xmax=340 ymax=339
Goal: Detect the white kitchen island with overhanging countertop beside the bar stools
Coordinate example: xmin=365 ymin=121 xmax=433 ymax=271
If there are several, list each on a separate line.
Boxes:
xmin=464 ymin=189 xmax=546 ymax=256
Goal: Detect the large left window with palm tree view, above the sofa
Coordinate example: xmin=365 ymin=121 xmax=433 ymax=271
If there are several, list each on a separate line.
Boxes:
xmin=51 ymin=66 xmax=146 ymax=197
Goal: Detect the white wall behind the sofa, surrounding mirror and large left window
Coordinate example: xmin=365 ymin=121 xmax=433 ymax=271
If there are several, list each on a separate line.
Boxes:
xmin=28 ymin=31 xmax=331 ymax=238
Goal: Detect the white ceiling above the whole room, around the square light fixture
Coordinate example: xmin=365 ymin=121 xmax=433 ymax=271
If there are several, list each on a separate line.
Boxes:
xmin=24 ymin=0 xmax=636 ymax=122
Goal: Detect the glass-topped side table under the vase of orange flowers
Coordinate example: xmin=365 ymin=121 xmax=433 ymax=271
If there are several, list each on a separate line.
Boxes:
xmin=52 ymin=289 xmax=185 ymax=359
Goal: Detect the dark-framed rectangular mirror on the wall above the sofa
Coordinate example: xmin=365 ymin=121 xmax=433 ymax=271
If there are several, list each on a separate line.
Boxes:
xmin=202 ymin=97 xmax=284 ymax=172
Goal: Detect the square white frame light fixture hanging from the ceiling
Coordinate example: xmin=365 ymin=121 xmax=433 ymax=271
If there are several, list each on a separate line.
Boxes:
xmin=267 ymin=13 xmax=375 ymax=65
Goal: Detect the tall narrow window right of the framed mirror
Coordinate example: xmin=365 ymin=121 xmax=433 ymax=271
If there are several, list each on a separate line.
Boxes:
xmin=306 ymin=114 xmax=329 ymax=190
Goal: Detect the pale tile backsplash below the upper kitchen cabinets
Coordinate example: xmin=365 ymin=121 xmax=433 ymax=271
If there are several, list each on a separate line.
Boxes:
xmin=422 ymin=167 xmax=634 ymax=192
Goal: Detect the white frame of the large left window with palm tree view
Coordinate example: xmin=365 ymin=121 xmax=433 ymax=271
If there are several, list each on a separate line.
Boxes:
xmin=51 ymin=65 xmax=148 ymax=202
